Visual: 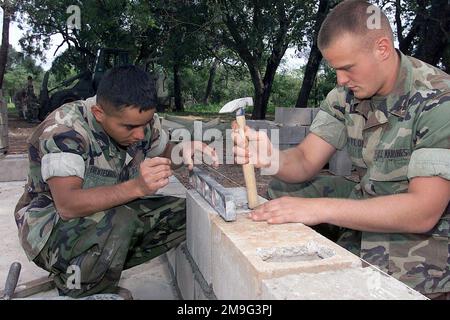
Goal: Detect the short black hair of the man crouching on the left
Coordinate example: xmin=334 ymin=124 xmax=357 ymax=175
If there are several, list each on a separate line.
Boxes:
xmin=97 ymin=65 xmax=157 ymax=112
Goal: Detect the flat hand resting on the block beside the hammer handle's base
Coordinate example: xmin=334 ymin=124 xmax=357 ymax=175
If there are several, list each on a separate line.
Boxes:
xmin=249 ymin=197 xmax=324 ymax=226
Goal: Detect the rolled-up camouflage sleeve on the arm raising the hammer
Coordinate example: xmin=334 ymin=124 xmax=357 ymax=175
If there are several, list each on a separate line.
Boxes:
xmin=309 ymin=89 xmax=347 ymax=150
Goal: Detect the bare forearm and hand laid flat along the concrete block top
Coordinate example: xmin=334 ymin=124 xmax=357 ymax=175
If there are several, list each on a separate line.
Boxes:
xmin=250 ymin=177 xmax=450 ymax=233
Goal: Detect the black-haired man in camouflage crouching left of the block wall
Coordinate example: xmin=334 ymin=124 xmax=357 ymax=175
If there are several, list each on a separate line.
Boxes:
xmin=15 ymin=66 xmax=218 ymax=297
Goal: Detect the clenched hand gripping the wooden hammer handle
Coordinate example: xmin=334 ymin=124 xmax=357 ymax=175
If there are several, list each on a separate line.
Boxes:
xmin=231 ymin=121 xmax=279 ymax=168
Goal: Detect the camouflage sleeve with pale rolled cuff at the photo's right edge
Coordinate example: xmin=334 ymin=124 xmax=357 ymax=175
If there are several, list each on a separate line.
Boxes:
xmin=408 ymin=93 xmax=450 ymax=180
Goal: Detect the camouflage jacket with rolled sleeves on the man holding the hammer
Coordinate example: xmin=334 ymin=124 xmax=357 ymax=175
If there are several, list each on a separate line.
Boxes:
xmin=310 ymin=54 xmax=450 ymax=293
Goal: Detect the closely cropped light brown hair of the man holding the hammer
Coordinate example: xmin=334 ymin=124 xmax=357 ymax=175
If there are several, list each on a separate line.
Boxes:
xmin=317 ymin=0 xmax=394 ymax=51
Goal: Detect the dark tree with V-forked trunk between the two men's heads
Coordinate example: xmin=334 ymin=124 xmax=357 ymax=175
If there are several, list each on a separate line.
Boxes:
xmin=210 ymin=0 xmax=313 ymax=119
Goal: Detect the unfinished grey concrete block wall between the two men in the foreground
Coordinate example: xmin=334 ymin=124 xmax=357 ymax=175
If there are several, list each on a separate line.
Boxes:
xmin=167 ymin=190 xmax=425 ymax=300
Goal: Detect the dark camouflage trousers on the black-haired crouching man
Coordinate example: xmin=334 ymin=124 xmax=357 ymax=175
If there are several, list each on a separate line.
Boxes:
xmin=34 ymin=197 xmax=186 ymax=298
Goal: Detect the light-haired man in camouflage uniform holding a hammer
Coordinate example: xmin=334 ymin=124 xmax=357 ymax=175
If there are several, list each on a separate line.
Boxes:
xmin=233 ymin=0 xmax=450 ymax=298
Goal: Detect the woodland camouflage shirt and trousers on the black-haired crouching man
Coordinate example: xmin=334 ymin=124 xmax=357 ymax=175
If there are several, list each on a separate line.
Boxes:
xmin=15 ymin=98 xmax=185 ymax=297
